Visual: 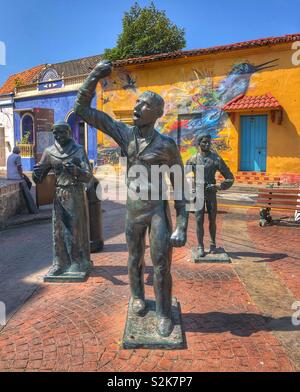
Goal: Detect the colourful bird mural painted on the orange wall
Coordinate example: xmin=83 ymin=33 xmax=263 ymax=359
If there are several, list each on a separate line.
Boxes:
xmin=102 ymin=59 xmax=278 ymax=158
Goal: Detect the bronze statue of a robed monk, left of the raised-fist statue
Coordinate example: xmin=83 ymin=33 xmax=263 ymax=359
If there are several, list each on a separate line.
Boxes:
xmin=32 ymin=122 xmax=92 ymax=281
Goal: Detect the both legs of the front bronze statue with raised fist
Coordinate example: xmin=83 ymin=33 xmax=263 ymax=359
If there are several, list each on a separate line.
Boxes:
xmin=126 ymin=203 xmax=173 ymax=336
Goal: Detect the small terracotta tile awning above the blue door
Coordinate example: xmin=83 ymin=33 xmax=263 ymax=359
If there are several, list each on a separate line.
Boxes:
xmin=223 ymin=93 xmax=281 ymax=112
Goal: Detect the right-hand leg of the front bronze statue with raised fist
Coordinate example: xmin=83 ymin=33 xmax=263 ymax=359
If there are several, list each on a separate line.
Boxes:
xmin=150 ymin=206 xmax=173 ymax=336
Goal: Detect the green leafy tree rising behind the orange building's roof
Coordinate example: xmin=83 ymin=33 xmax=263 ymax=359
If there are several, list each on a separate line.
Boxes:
xmin=103 ymin=2 xmax=186 ymax=61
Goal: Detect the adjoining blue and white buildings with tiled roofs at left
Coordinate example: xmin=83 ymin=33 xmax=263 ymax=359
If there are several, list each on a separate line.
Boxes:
xmin=0 ymin=56 xmax=101 ymax=171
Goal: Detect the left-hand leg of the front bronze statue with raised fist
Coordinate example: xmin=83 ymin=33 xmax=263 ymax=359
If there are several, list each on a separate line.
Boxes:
xmin=126 ymin=215 xmax=148 ymax=314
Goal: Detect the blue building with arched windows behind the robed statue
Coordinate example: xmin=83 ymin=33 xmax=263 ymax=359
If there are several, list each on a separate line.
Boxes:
xmin=14 ymin=56 xmax=100 ymax=170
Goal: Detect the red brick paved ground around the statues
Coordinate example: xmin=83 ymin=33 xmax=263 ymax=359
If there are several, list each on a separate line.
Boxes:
xmin=0 ymin=202 xmax=300 ymax=372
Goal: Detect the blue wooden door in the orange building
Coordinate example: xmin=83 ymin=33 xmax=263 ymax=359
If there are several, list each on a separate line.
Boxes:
xmin=240 ymin=115 xmax=268 ymax=172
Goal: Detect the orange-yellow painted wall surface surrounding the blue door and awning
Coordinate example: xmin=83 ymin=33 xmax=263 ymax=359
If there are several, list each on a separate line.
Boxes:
xmin=97 ymin=44 xmax=300 ymax=174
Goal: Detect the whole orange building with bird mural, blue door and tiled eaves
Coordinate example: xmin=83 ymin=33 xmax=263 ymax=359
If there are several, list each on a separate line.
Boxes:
xmin=97 ymin=34 xmax=300 ymax=183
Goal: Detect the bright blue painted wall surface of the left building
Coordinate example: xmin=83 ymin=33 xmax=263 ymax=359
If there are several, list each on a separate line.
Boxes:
xmin=14 ymin=91 xmax=97 ymax=163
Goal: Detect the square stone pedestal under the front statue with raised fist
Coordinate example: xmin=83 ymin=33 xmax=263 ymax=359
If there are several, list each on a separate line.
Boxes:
xmin=122 ymin=297 xmax=185 ymax=350
